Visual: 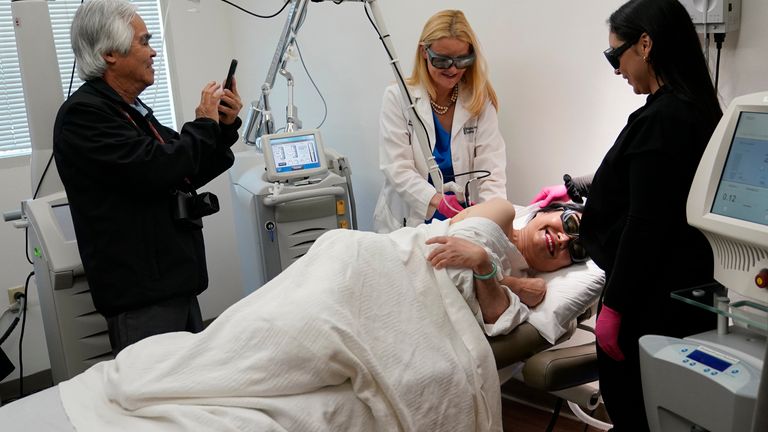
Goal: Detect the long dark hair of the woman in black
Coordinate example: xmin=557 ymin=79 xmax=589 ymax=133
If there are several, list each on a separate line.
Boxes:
xmin=608 ymin=0 xmax=723 ymax=124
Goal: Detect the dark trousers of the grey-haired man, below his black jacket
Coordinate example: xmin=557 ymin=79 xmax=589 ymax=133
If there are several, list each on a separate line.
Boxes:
xmin=107 ymin=296 xmax=203 ymax=356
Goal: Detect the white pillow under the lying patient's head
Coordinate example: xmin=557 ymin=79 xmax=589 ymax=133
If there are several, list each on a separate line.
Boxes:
xmin=528 ymin=260 xmax=605 ymax=345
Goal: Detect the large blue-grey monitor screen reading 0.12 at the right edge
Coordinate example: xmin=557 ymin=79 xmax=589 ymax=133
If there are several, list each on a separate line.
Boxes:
xmin=712 ymin=112 xmax=768 ymax=225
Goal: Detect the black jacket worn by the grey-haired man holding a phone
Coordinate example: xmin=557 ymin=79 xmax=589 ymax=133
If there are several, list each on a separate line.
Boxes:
xmin=53 ymin=79 xmax=241 ymax=316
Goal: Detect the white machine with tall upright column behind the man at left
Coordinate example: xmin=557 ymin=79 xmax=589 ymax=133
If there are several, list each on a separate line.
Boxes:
xmin=4 ymin=0 xmax=112 ymax=384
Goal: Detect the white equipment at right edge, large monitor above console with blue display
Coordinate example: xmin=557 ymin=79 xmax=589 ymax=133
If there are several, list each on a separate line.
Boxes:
xmin=640 ymin=92 xmax=768 ymax=432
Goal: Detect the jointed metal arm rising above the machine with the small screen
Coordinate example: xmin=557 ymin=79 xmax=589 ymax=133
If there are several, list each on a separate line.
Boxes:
xmin=243 ymin=0 xmax=309 ymax=145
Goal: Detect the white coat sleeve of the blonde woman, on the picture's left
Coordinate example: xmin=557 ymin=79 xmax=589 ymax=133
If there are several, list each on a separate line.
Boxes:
xmin=379 ymin=86 xmax=436 ymax=219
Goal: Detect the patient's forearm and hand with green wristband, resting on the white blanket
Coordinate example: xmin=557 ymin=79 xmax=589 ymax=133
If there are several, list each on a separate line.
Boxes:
xmin=427 ymin=236 xmax=510 ymax=324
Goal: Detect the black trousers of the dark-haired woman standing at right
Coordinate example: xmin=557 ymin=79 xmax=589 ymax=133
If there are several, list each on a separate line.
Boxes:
xmin=595 ymin=344 xmax=649 ymax=432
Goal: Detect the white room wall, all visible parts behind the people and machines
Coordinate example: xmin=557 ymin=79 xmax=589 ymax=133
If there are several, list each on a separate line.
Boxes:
xmin=0 ymin=0 xmax=768 ymax=384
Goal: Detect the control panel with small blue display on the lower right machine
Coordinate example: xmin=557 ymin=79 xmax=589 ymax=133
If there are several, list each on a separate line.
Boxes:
xmin=655 ymin=343 xmax=760 ymax=391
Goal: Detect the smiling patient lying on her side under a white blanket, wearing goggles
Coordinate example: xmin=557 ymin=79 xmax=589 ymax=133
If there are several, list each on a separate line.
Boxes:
xmin=60 ymin=200 xmax=581 ymax=432
